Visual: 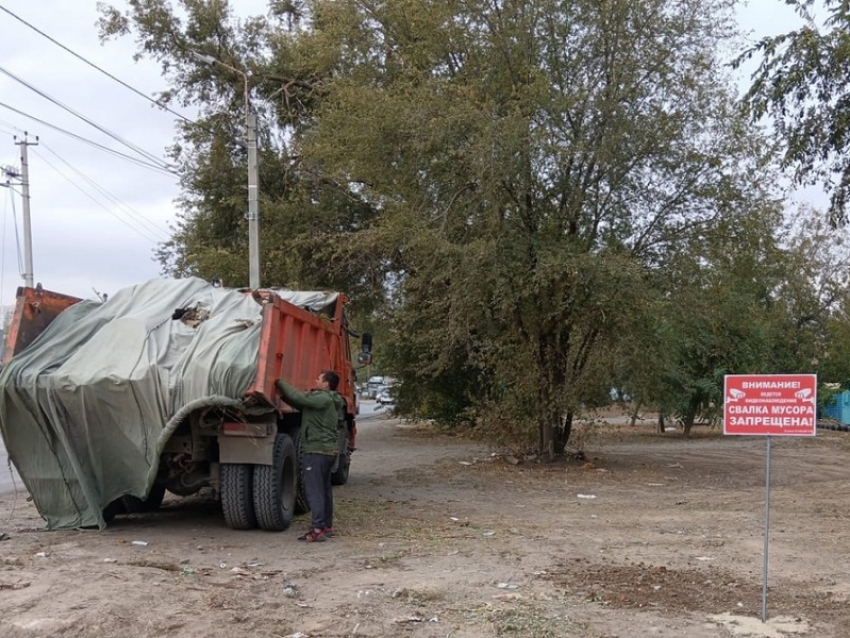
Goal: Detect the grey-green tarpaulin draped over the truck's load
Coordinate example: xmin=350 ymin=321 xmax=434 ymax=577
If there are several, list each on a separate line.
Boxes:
xmin=0 ymin=279 xmax=262 ymax=529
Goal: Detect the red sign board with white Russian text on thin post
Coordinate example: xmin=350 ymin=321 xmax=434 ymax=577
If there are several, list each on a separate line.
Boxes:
xmin=723 ymin=374 xmax=817 ymax=436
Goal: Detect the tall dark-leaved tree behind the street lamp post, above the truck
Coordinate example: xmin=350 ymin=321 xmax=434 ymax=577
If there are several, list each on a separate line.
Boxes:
xmin=95 ymin=0 xmax=382 ymax=311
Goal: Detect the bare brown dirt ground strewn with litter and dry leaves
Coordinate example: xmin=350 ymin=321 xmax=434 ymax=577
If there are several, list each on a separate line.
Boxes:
xmin=0 ymin=410 xmax=850 ymax=638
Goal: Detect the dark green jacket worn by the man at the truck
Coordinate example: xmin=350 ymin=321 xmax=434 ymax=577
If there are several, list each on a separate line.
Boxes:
xmin=276 ymin=379 xmax=344 ymax=454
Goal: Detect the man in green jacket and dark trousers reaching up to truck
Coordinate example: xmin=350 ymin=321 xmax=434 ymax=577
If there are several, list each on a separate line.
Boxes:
xmin=276 ymin=370 xmax=343 ymax=543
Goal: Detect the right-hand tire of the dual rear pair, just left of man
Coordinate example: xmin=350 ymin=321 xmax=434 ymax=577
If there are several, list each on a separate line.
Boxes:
xmin=254 ymin=434 xmax=298 ymax=532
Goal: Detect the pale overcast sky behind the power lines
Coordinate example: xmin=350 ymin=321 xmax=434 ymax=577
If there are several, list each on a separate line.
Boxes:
xmin=0 ymin=0 xmax=820 ymax=305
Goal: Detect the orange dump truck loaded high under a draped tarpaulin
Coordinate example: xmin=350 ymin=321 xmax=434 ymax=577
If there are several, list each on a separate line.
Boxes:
xmin=0 ymin=278 xmax=371 ymax=530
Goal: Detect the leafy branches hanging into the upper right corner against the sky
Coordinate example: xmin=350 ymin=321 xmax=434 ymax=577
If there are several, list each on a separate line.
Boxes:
xmin=735 ymin=0 xmax=850 ymax=224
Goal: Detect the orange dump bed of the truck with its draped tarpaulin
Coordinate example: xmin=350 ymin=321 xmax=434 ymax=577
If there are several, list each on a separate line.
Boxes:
xmin=0 ymin=279 xmax=356 ymax=528
